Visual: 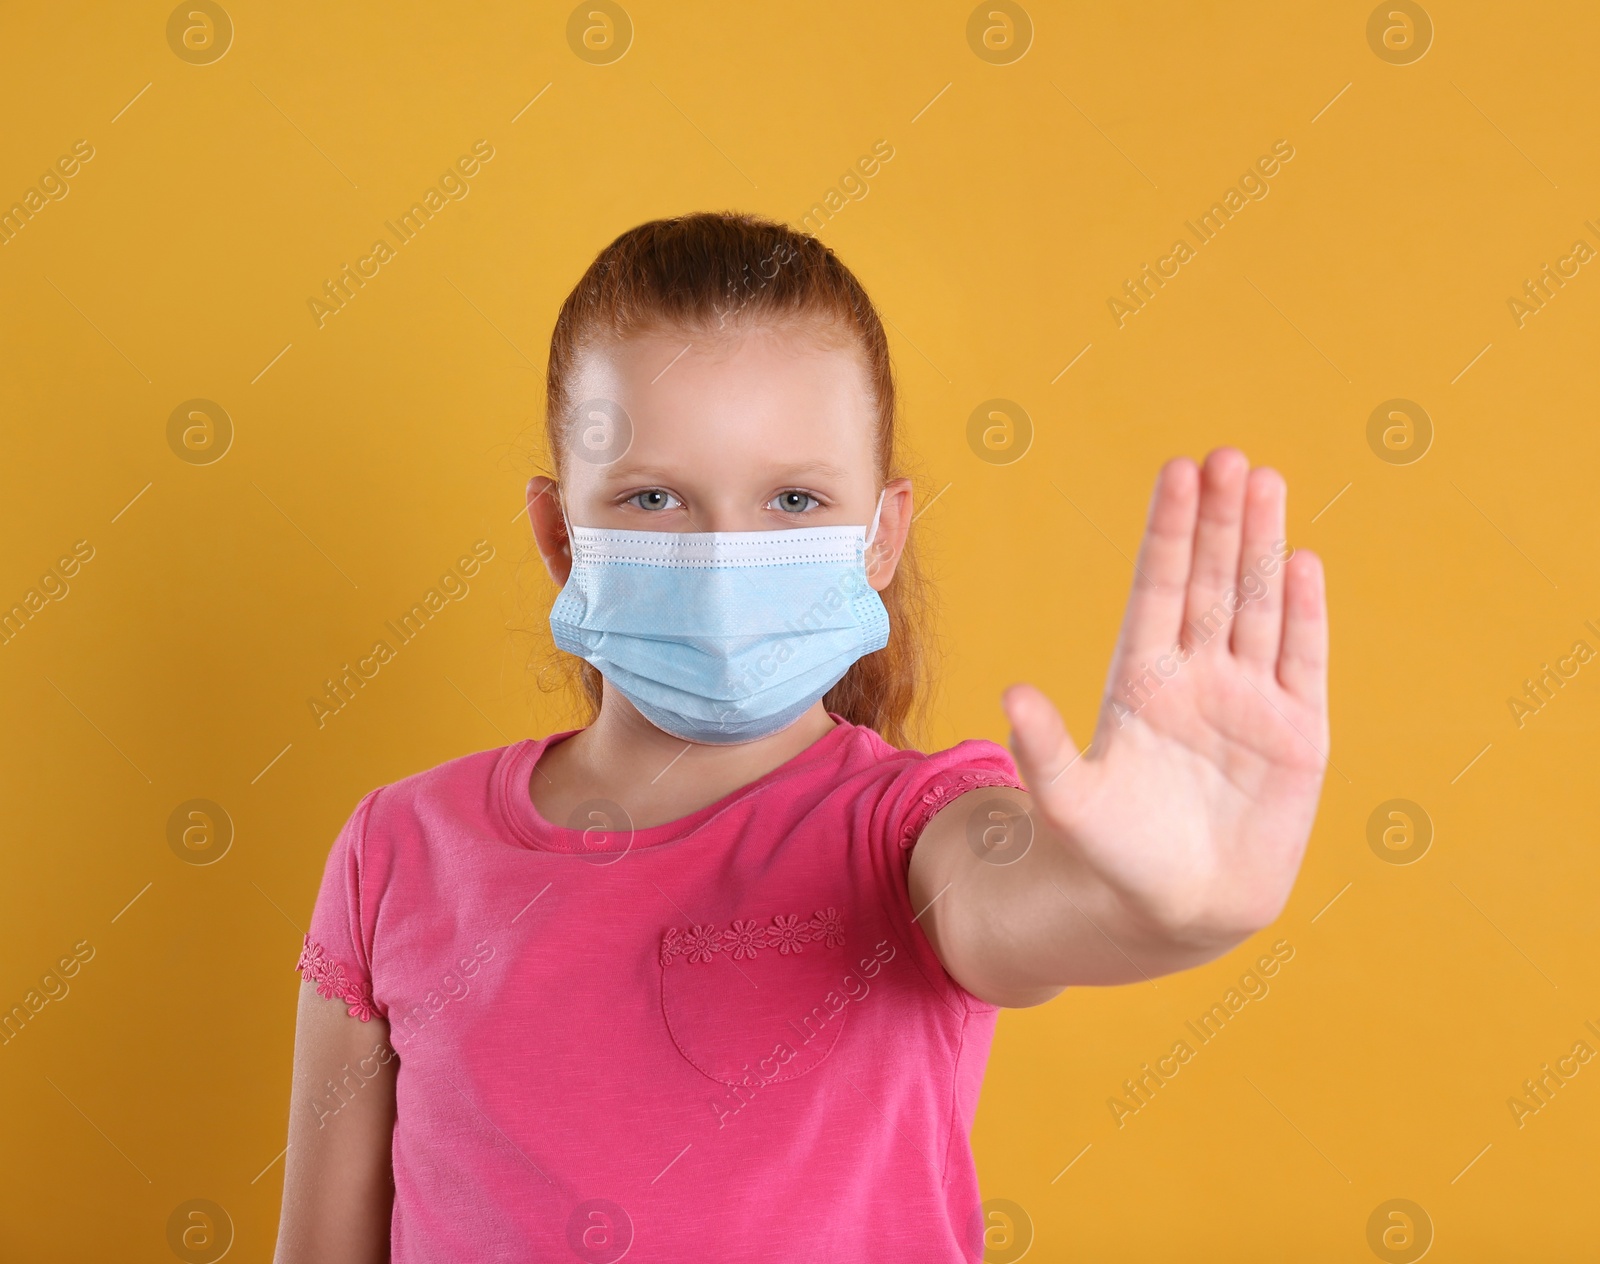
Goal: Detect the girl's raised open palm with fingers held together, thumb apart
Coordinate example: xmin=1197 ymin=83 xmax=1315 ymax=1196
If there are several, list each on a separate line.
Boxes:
xmin=1005 ymin=448 xmax=1328 ymax=942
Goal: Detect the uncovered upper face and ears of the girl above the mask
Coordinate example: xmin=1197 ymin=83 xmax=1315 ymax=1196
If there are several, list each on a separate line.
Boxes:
xmin=528 ymin=328 xmax=910 ymax=589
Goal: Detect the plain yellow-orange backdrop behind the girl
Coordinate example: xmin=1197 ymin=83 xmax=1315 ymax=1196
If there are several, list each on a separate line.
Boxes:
xmin=0 ymin=0 xmax=1600 ymax=1261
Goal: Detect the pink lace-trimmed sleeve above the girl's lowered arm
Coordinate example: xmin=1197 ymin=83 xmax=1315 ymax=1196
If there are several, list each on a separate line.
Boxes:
xmin=296 ymin=790 xmax=382 ymax=1022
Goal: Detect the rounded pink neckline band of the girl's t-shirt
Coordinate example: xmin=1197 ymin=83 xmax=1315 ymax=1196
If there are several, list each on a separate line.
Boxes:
xmin=496 ymin=712 xmax=858 ymax=856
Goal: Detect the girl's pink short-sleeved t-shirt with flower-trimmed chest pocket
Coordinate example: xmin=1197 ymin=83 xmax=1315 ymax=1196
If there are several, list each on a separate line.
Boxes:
xmin=299 ymin=717 xmax=1021 ymax=1264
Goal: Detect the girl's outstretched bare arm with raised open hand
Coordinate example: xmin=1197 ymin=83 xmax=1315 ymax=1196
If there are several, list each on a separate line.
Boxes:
xmin=910 ymin=448 xmax=1328 ymax=1006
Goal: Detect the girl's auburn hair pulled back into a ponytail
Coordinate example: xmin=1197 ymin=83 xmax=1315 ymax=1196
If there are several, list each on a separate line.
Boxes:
xmin=541 ymin=211 xmax=931 ymax=747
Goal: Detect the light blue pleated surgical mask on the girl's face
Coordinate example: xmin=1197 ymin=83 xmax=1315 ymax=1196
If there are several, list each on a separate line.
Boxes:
xmin=550 ymin=494 xmax=890 ymax=746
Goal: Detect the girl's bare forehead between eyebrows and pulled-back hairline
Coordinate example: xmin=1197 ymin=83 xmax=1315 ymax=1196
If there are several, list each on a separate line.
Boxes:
xmin=570 ymin=323 xmax=877 ymax=478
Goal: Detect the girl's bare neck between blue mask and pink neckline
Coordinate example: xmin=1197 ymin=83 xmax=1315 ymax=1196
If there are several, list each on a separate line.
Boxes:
xmin=530 ymin=683 xmax=835 ymax=829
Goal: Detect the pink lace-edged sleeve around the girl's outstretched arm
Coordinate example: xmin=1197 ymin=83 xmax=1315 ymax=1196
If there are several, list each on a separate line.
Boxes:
xmin=877 ymin=738 xmax=1026 ymax=1011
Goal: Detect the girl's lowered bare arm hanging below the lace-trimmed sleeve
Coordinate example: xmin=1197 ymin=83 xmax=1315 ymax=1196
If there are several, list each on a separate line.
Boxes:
xmin=272 ymin=982 xmax=398 ymax=1264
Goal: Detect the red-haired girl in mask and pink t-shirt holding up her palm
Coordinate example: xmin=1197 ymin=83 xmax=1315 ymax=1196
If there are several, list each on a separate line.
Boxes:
xmin=277 ymin=214 xmax=1328 ymax=1264
